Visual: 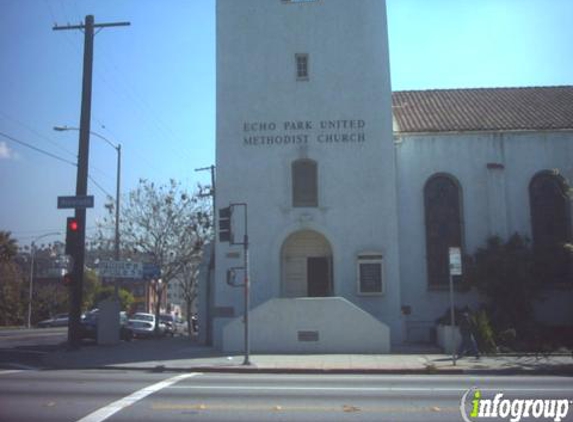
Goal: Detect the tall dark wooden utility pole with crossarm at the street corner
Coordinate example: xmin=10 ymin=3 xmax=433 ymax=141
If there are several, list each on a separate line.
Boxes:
xmin=53 ymin=15 xmax=130 ymax=349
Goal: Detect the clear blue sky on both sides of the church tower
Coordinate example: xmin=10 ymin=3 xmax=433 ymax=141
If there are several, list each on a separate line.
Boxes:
xmin=0 ymin=0 xmax=573 ymax=249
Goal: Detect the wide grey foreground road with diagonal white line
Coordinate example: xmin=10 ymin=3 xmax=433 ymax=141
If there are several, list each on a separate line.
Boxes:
xmin=0 ymin=370 xmax=573 ymax=422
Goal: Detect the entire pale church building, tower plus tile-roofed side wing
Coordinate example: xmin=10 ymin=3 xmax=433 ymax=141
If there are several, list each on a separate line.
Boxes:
xmin=199 ymin=0 xmax=573 ymax=353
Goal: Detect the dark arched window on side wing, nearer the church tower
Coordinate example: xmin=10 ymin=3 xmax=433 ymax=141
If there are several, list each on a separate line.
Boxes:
xmin=424 ymin=175 xmax=462 ymax=287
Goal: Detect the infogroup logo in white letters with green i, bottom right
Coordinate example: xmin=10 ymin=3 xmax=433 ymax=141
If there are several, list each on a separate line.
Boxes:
xmin=460 ymin=388 xmax=573 ymax=422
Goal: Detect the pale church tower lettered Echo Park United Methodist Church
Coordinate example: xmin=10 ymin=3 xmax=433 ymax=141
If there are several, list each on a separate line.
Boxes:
xmin=210 ymin=0 xmax=403 ymax=352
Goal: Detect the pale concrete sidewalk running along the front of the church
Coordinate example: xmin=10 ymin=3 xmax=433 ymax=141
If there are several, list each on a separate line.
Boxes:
xmin=43 ymin=337 xmax=573 ymax=376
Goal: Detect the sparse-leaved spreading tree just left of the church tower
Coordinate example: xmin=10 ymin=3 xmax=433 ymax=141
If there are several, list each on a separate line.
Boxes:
xmin=97 ymin=179 xmax=211 ymax=329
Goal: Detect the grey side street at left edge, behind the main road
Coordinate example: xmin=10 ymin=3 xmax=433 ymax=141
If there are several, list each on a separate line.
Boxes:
xmin=0 ymin=327 xmax=68 ymax=369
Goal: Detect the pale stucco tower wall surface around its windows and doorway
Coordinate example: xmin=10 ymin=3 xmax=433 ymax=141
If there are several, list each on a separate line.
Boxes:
xmin=215 ymin=0 xmax=402 ymax=346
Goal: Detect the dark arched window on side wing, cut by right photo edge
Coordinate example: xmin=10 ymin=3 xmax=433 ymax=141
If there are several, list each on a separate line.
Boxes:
xmin=529 ymin=171 xmax=572 ymax=283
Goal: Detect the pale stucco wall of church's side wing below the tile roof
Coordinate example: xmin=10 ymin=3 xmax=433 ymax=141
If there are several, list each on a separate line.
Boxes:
xmin=396 ymin=131 xmax=573 ymax=342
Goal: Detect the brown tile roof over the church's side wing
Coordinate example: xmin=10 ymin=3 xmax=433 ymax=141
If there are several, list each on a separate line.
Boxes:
xmin=392 ymin=86 xmax=573 ymax=132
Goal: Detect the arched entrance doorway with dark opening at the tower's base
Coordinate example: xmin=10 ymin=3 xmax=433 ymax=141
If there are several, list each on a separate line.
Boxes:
xmin=281 ymin=230 xmax=333 ymax=297
